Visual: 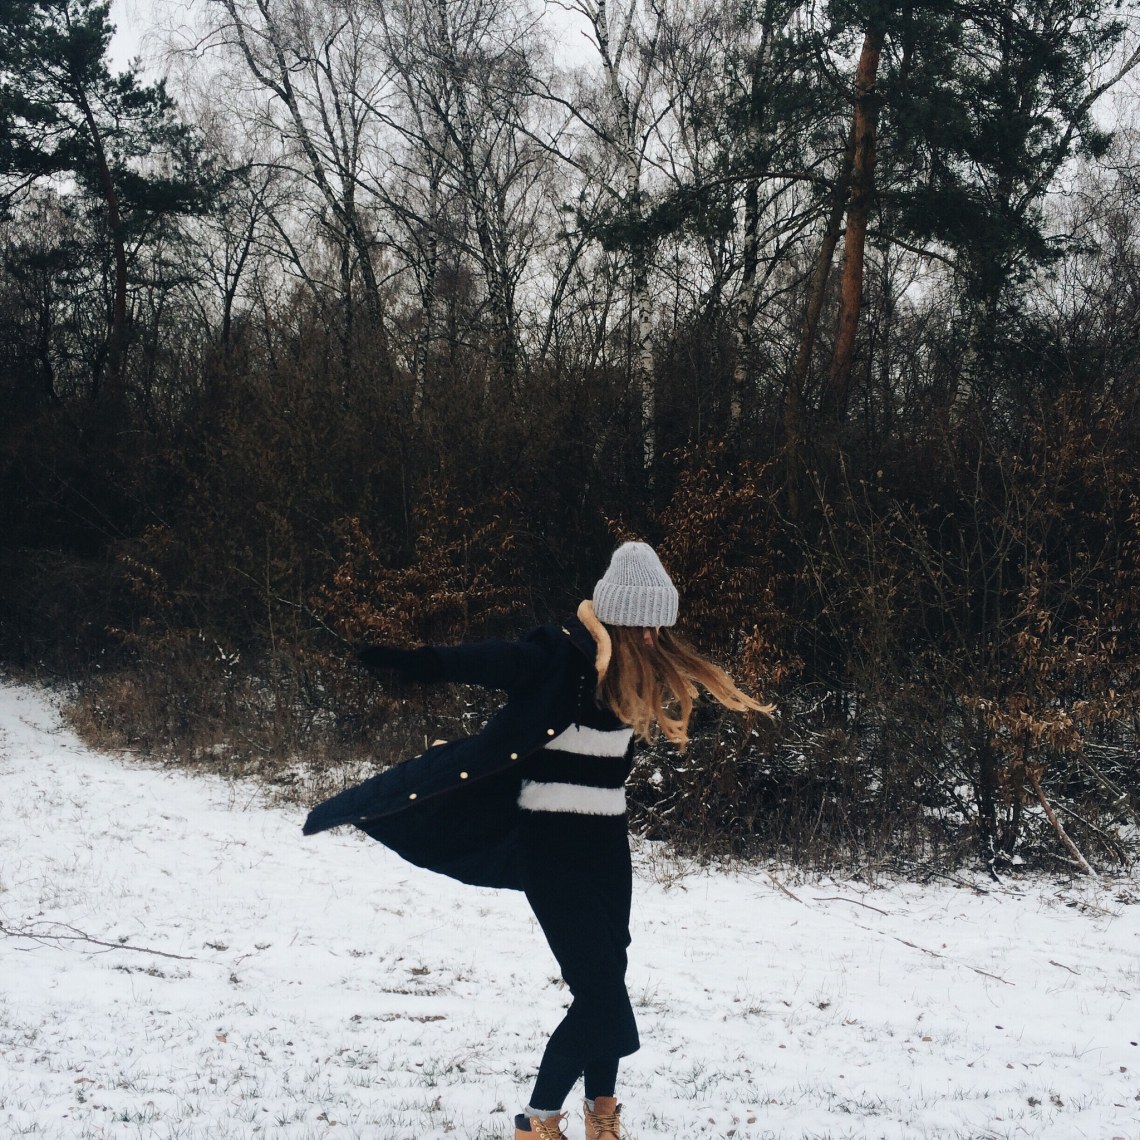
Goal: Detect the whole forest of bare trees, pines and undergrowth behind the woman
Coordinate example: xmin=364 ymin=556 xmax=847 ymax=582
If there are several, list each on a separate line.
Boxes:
xmin=0 ymin=0 xmax=1140 ymax=874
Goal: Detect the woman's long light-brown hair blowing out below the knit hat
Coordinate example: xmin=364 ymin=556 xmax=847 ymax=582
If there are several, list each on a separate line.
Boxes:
xmin=597 ymin=626 xmax=775 ymax=750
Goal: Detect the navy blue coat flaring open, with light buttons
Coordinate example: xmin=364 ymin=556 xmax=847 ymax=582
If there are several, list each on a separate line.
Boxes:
xmin=304 ymin=618 xmax=596 ymax=890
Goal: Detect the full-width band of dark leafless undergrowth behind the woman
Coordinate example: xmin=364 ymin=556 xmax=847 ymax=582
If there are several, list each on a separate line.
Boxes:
xmin=0 ymin=202 xmax=1140 ymax=870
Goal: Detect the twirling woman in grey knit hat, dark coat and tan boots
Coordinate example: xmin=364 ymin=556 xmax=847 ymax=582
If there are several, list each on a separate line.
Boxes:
xmin=304 ymin=543 xmax=772 ymax=1140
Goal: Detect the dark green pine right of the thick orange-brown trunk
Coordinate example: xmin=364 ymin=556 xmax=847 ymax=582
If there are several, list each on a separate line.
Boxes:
xmin=886 ymin=0 xmax=1140 ymax=404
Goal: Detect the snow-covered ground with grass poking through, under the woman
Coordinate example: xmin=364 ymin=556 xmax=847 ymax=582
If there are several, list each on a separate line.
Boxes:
xmin=0 ymin=685 xmax=1140 ymax=1140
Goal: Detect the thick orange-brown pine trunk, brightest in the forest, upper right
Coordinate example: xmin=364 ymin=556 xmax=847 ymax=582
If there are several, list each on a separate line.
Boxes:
xmin=820 ymin=27 xmax=882 ymax=424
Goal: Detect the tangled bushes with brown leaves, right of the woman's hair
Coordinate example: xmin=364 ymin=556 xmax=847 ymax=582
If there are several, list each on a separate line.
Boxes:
xmin=615 ymin=402 xmax=1140 ymax=869
